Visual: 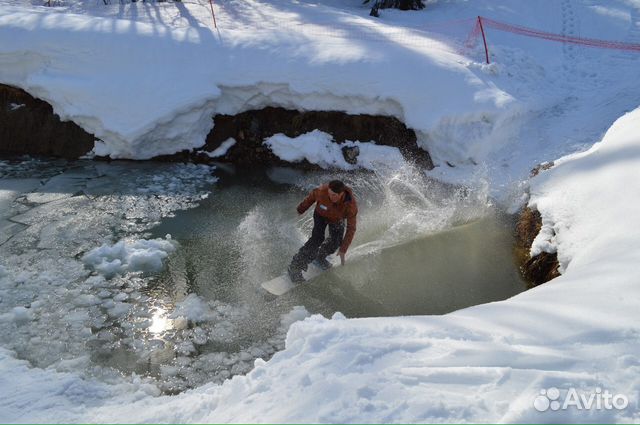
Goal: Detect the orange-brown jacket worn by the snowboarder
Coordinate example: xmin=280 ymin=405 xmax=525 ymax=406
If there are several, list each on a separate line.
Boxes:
xmin=298 ymin=184 xmax=358 ymax=252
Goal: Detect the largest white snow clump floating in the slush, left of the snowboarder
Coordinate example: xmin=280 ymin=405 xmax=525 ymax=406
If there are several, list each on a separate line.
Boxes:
xmin=82 ymin=235 xmax=176 ymax=279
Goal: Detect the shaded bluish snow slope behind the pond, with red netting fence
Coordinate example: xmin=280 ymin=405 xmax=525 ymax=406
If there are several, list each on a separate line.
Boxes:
xmin=0 ymin=0 xmax=640 ymax=190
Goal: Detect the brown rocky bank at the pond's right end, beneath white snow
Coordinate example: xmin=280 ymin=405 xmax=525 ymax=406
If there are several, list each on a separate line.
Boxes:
xmin=515 ymin=207 xmax=560 ymax=288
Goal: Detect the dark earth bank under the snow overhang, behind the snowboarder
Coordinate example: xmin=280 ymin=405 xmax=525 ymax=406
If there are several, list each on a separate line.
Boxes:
xmin=204 ymin=107 xmax=433 ymax=168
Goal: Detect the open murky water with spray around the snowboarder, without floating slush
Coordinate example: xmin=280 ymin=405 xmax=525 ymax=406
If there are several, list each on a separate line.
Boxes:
xmin=154 ymin=164 xmax=525 ymax=317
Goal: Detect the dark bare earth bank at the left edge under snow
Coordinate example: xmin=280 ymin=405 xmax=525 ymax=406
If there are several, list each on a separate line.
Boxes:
xmin=0 ymin=84 xmax=95 ymax=159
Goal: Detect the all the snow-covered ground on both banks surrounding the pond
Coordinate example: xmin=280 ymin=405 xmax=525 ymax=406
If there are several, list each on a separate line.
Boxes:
xmin=0 ymin=0 xmax=640 ymax=423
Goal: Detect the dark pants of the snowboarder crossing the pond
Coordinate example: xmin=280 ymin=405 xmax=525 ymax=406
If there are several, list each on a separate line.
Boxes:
xmin=291 ymin=211 xmax=344 ymax=271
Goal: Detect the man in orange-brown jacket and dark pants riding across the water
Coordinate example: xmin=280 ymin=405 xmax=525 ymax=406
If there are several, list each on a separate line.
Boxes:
xmin=288 ymin=180 xmax=358 ymax=283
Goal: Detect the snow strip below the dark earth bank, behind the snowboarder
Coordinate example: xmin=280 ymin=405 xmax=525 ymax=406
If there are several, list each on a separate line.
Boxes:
xmin=263 ymin=130 xmax=405 ymax=170
